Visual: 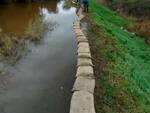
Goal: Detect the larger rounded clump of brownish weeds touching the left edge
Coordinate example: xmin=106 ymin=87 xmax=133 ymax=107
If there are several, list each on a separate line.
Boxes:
xmin=0 ymin=34 xmax=25 ymax=64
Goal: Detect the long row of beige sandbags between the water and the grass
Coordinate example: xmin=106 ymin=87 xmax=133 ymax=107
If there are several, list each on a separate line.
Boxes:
xmin=70 ymin=9 xmax=95 ymax=113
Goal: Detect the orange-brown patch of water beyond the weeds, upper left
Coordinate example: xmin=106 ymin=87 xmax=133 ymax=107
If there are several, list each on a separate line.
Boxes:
xmin=0 ymin=0 xmax=57 ymax=35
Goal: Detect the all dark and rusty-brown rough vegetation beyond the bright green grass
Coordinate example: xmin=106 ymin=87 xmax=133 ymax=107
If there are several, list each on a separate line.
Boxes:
xmin=97 ymin=0 xmax=150 ymax=45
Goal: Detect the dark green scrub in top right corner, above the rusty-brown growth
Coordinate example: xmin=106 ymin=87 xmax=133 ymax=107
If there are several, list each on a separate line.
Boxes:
xmin=105 ymin=0 xmax=150 ymax=17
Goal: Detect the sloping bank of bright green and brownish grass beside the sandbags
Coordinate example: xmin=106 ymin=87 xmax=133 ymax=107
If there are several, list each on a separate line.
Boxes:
xmin=85 ymin=0 xmax=150 ymax=113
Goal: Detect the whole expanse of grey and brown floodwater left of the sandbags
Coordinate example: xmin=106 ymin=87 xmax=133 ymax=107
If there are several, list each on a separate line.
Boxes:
xmin=0 ymin=2 xmax=76 ymax=113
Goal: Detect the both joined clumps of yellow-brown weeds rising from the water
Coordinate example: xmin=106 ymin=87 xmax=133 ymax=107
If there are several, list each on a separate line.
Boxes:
xmin=0 ymin=16 xmax=47 ymax=64
